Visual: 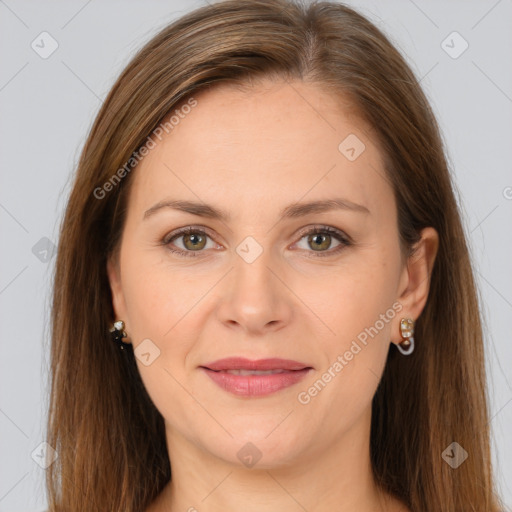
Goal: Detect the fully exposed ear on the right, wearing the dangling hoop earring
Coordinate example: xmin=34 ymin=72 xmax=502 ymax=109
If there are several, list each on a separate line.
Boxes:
xmin=391 ymin=227 xmax=439 ymax=344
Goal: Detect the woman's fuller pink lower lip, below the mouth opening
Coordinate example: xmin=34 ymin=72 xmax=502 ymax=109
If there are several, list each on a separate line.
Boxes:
xmin=202 ymin=368 xmax=311 ymax=396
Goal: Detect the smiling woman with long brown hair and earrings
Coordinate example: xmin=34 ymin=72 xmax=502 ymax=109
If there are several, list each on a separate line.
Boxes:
xmin=47 ymin=0 xmax=506 ymax=512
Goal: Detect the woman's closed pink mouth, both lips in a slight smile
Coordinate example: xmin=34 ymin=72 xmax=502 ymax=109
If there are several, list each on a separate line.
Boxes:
xmin=200 ymin=357 xmax=313 ymax=397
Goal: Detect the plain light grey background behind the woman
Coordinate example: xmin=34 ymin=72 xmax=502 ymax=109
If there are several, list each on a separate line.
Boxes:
xmin=0 ymin=0 xmax=512 ymax=511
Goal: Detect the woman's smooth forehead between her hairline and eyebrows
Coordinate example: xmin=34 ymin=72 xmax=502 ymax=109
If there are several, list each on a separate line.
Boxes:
xmin=130 ymin=82 xmax=393 ymax=222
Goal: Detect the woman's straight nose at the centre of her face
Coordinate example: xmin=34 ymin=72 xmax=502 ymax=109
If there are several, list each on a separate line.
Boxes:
xmin=217 ymin=247 xmax=293 ymax=336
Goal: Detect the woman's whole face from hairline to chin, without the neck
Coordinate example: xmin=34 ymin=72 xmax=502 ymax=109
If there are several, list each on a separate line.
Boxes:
xmin=108 ymin=82 xmax=432 ymax=467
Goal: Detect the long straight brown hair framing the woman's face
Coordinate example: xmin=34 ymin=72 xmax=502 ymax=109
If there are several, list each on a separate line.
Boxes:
xmin=46 ymin=0 xmax=506 ymax=512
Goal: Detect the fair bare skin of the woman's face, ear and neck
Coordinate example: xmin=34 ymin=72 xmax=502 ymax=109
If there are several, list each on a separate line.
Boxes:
xmin=108 ymin=78 xmax=438 ymax=512
